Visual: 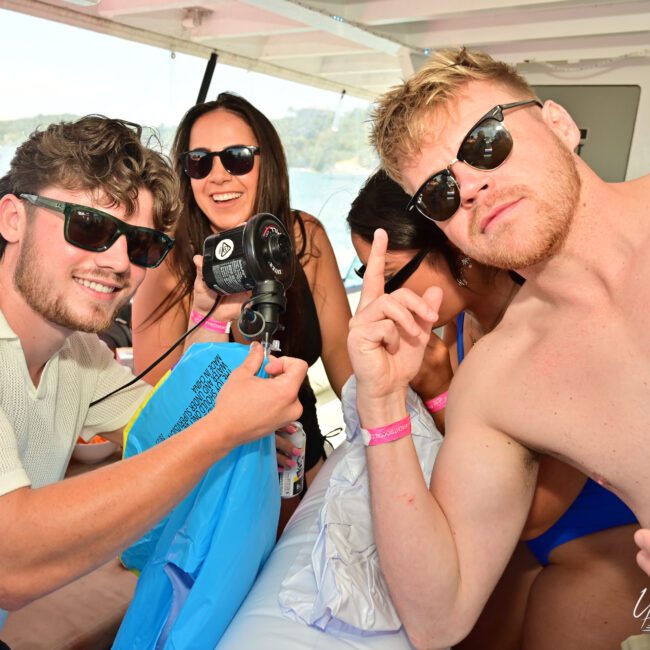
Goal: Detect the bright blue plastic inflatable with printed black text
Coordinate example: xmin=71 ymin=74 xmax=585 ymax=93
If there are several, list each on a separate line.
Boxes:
xmin=113 ymin=343 xmax=280 ymax=650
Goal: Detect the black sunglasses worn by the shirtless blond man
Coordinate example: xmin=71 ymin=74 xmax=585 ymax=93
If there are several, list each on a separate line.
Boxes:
xmin=407 ymin=99 xmax=543 ymax=221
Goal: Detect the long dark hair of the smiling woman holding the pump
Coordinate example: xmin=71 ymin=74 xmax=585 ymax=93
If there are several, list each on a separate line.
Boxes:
xmin=151 ymin=92 xmax=311 ymax=356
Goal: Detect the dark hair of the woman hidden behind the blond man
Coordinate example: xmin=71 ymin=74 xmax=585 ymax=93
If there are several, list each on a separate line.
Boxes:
xmin=347 ymin=169 xmax=463 ymax=282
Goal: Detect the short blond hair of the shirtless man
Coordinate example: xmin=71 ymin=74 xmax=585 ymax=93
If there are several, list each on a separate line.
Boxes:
xmin=370 ymin=47 xmax=536 ymax=183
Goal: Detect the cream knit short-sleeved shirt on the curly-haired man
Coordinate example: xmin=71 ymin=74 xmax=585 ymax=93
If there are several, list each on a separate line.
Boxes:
xmin=0 ymin=312 xmax=150 ymax=495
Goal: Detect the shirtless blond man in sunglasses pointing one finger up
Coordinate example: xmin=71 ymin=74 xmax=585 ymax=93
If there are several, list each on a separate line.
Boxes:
xmin=348 ymin=50 xmax=650 ymax=648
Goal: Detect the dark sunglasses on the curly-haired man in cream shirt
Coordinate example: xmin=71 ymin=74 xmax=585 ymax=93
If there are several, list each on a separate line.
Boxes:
xmin=18 ymin=194 xmax=174 ymax=269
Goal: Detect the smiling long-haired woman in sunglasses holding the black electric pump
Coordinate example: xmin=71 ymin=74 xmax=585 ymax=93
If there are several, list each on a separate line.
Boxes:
xmin=133 ymin=93 xmax=351 ymax=528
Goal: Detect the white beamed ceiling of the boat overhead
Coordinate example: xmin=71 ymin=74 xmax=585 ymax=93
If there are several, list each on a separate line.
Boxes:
xmin=5 ymin=0 xmax=650 ymax=99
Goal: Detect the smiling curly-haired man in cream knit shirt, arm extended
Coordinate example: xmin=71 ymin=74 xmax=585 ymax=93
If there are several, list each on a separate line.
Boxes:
xmin=0 ymin=116 xmax=306 ymax=627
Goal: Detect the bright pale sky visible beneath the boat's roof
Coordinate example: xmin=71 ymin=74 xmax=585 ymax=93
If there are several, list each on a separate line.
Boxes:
xmin=0 ymin=9 xmax=367 ymax=126
